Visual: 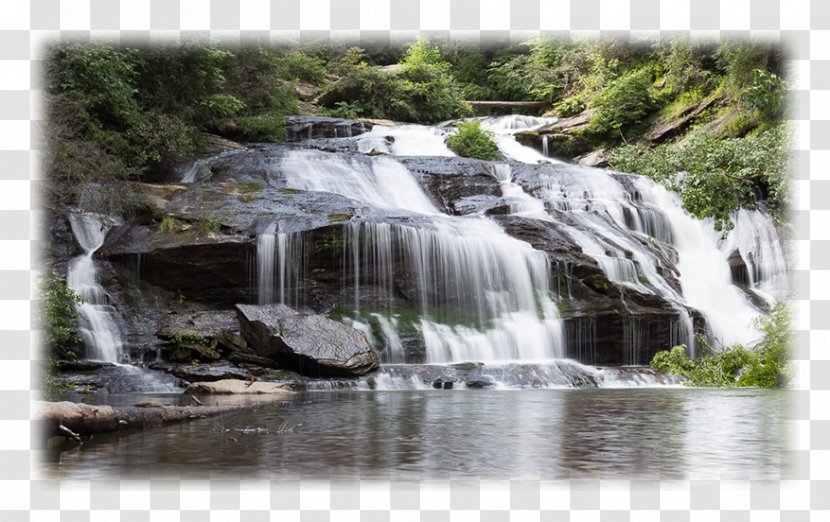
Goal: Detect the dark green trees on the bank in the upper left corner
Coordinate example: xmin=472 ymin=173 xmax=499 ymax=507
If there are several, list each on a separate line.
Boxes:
xmin=46 ymin=44 xmax=300 ymax=201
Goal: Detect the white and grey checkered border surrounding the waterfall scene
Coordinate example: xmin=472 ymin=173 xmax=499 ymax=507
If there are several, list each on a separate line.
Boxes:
xmin=0 ymin=0 xmax=830 ymax=522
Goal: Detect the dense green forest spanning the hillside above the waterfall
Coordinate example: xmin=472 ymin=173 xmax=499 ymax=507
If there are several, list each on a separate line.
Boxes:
xmin=47 ymin=39 xmax=788 ymax=228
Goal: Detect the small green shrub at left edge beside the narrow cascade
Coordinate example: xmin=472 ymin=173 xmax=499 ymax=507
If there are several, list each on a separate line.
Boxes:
xmin=41 ymin=272 xmax=82 ymax=357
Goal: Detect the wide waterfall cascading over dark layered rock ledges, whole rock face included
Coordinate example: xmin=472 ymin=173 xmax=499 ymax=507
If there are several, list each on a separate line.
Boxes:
xmin=55 ymin=116 xmax=787 ymax=389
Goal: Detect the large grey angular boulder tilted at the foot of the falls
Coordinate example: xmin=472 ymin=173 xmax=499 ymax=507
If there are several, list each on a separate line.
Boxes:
xmin=236 ymin=304 xmax=379 ymax=377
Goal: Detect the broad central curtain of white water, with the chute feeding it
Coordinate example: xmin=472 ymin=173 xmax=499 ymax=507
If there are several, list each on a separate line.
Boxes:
xmin=282 ymin=151 xmax=563 ymax=363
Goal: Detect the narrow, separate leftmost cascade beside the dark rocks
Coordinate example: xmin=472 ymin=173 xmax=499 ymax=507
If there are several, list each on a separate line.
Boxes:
xmin=66 ymin=214 xmax=122 ymax=363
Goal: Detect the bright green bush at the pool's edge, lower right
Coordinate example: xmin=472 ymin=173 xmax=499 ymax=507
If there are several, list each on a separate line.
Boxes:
xmin=651 ymin=303 xmax=791 ymax=388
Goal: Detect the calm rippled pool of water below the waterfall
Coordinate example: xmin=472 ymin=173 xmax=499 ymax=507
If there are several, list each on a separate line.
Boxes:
xmin=41 ymin=387 xmax=787 ymax=480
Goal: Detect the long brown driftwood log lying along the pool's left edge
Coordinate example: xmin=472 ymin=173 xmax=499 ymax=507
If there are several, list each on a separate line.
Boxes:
xmin=35 ymin=402 xmax=251 ymax=440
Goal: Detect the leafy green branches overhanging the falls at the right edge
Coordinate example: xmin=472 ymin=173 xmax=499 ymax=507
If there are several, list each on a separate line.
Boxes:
xmin=611 ymin=126 xmax=789 ymax=230
